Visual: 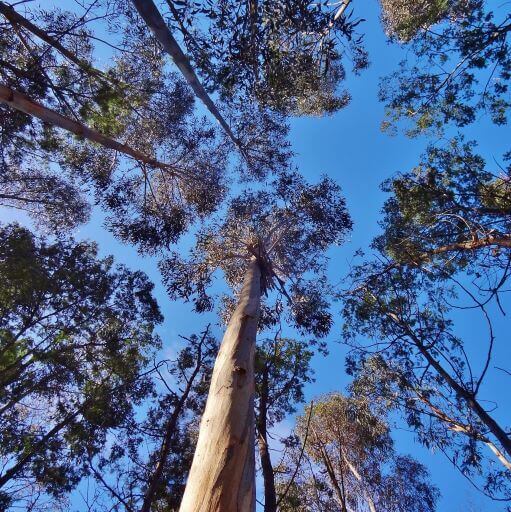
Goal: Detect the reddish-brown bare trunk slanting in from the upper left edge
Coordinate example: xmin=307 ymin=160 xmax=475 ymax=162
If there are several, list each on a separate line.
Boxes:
xmin=0 ymin=85 xmax=177 ymax=174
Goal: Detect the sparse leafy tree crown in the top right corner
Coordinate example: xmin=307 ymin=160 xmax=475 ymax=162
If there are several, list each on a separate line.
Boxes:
xmin=380 ymin=0 xmax=511 ymax=135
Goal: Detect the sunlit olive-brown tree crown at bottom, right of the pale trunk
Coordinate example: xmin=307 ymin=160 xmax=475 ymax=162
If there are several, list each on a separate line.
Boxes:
xmin=279 ymin=393 xmax=439 ymax=512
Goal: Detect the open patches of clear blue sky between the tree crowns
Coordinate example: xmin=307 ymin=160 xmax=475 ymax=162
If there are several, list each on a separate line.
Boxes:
xmin=4 ymin=0 xmax=511 ymax=512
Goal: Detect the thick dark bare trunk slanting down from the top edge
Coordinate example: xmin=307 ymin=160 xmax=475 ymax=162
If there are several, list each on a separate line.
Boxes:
xmin=132 ymin=0 xmax=240 ymax=147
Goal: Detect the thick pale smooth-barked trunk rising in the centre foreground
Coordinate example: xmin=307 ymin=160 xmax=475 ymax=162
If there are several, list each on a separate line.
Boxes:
xmin=180 ymin=258 xmax=261 ymax=512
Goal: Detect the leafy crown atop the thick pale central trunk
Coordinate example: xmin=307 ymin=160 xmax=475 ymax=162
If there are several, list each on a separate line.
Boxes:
xmin=161 ymin=173 xmax=351 ymax=336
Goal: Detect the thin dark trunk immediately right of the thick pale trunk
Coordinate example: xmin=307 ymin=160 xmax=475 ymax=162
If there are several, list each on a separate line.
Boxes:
xmin=257 ymin=366 xmax=277 ymax=512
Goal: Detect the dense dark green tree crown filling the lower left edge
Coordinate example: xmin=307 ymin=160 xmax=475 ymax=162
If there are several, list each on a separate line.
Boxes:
xmin=0 ymin=224 xmax=162 ymax=509
